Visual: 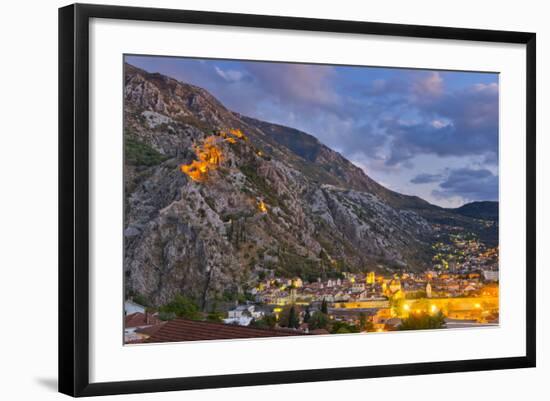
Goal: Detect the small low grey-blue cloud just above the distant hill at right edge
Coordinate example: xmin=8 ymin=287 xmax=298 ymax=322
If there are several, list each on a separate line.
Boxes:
xmin=432 ymin=168 xmax=498 ymax=201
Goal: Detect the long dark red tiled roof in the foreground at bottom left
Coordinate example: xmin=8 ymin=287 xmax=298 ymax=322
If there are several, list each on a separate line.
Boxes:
xmin=146 ymin=319 xmax=305 ymax=343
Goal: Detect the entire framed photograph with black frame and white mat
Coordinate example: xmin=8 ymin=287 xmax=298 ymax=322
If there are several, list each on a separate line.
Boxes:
xmin=59 ymin=4 xmax=536 ymax=396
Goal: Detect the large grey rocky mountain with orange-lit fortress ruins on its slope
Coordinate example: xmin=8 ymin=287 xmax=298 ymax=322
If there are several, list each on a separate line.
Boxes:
xmin=124 ymin=64 xmax=500 ymax=305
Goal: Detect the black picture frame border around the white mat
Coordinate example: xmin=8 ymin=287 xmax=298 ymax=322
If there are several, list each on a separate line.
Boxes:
xmin=59 ymin=4 xmax=536 ymax=396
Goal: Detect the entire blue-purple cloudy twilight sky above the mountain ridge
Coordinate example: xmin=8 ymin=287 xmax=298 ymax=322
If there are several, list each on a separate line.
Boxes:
xmin=126 ymin=56 xmax=499 ymax=207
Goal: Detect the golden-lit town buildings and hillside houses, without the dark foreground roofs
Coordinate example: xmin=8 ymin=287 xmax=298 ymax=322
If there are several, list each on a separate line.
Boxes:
xmin=237 ymin=230 xmax=499 ymax=331
